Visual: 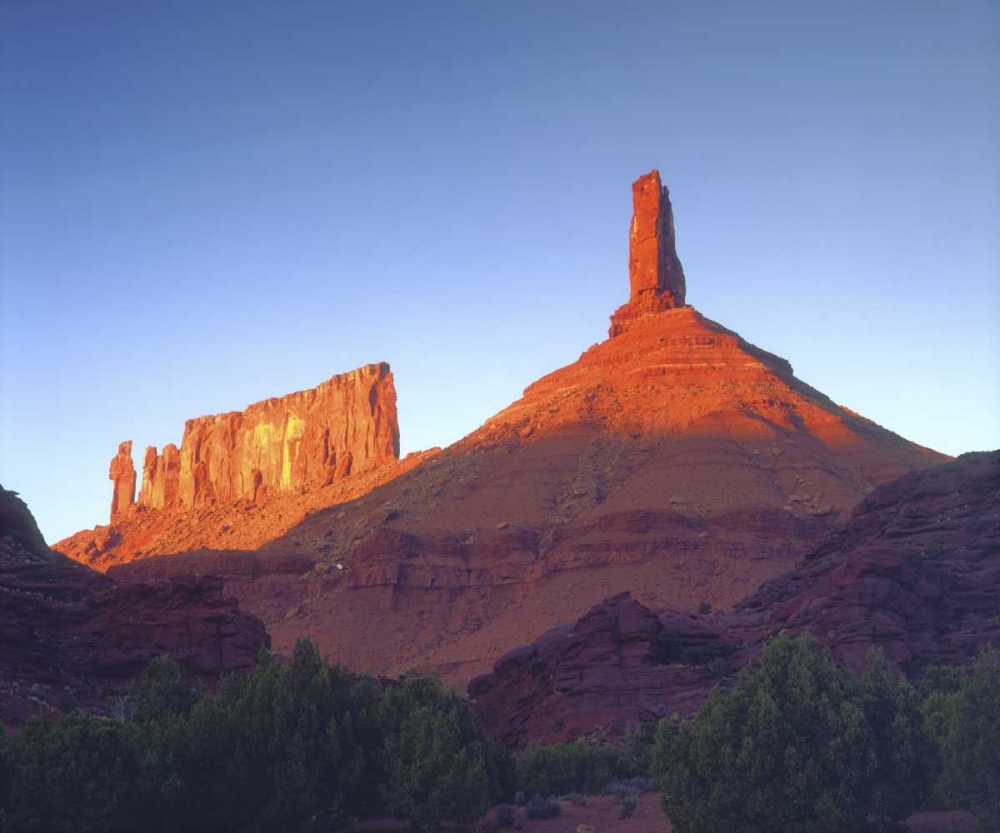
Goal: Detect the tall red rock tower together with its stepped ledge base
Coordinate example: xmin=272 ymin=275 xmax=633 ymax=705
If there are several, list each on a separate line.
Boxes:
xmin=608 ymin=168 xmax=686 ymax=338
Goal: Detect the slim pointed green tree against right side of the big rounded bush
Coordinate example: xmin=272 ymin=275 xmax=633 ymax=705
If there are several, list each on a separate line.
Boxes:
xmin=861 ymin=649 xmax=933 ymax=824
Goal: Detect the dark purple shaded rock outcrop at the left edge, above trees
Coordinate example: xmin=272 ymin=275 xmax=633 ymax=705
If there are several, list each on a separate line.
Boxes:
xmin=0 ymin=488 xmax=269 ymax=724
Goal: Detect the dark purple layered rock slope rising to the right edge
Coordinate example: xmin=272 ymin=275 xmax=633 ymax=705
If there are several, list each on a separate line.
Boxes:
xmin=748 ymin=451 xmax=1000 ymax=677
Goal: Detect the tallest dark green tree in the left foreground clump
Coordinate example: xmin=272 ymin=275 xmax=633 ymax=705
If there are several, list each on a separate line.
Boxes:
xmin=166 ymin=640 xmax=378 ymax=831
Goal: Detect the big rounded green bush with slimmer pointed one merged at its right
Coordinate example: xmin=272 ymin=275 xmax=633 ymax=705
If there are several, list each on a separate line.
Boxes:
xmin=653 ymin=634 xmax=921 ymax=833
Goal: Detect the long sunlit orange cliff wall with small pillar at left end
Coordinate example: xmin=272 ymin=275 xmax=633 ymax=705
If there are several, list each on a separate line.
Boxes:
xmin=112 ymin=363 xmax=399 ymax=519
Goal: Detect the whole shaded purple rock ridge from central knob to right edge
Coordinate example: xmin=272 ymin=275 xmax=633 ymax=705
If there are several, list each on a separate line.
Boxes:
xmin=468 ymin=452 xmax=1000 ymax=746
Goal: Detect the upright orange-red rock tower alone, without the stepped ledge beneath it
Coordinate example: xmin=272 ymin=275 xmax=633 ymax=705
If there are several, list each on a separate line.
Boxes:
xmin=628 ymin=168 xmax=685 ymax=308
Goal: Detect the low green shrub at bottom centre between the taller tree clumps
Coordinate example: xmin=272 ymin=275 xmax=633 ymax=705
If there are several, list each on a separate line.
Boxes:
xmin=517 ymin=740 xmax=633 ymax=795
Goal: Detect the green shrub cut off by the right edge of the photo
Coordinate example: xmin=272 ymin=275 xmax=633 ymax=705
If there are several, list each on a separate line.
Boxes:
xmin=922 ymin=648 xmax=1000 ymax=831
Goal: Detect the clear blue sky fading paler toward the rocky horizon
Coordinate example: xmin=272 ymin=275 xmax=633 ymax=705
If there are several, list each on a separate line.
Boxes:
xmin=0 ymin=0 xmax=1000 ymax=542
